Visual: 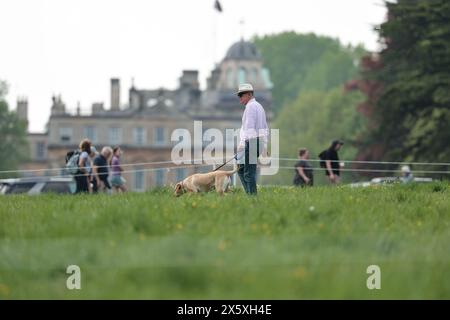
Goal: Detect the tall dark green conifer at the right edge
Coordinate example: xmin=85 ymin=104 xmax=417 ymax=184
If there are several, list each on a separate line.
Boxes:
xmin=360 ymin=0 xmax=450 ymax=162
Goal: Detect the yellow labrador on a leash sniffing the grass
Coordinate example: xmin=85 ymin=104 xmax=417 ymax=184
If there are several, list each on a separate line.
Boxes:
xmin=175 ymin=166 xmax=238 ymax=197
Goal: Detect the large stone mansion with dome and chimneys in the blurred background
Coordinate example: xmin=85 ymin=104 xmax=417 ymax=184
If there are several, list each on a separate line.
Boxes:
xmin=17 ymin=40 xmax=272 ymax=191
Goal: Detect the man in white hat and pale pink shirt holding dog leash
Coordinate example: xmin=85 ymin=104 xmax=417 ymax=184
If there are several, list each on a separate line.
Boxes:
xmin=236 ymin=83 xmax=269 ymax=195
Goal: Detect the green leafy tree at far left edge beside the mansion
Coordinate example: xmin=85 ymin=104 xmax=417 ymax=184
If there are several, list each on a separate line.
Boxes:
xmin=0 ymin=81 xmax=28 ymax=177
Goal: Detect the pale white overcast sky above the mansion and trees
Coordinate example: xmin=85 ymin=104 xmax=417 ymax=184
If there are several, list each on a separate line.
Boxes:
xmin=0 ymin=0 xmax=386 ymax=132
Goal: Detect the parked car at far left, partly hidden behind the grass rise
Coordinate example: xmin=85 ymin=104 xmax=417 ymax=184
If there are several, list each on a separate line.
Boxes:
xmin=0 ymin=177 xmax=76 ymax=195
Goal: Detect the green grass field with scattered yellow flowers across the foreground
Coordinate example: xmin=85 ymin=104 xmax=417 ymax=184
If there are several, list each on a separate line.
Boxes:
xmin=0 ymin=183 xmax=450 ymax=299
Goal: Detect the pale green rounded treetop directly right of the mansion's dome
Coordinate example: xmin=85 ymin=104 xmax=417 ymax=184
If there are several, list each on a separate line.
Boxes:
xmin=254 ymin=32 xmax=365 ymax=113
